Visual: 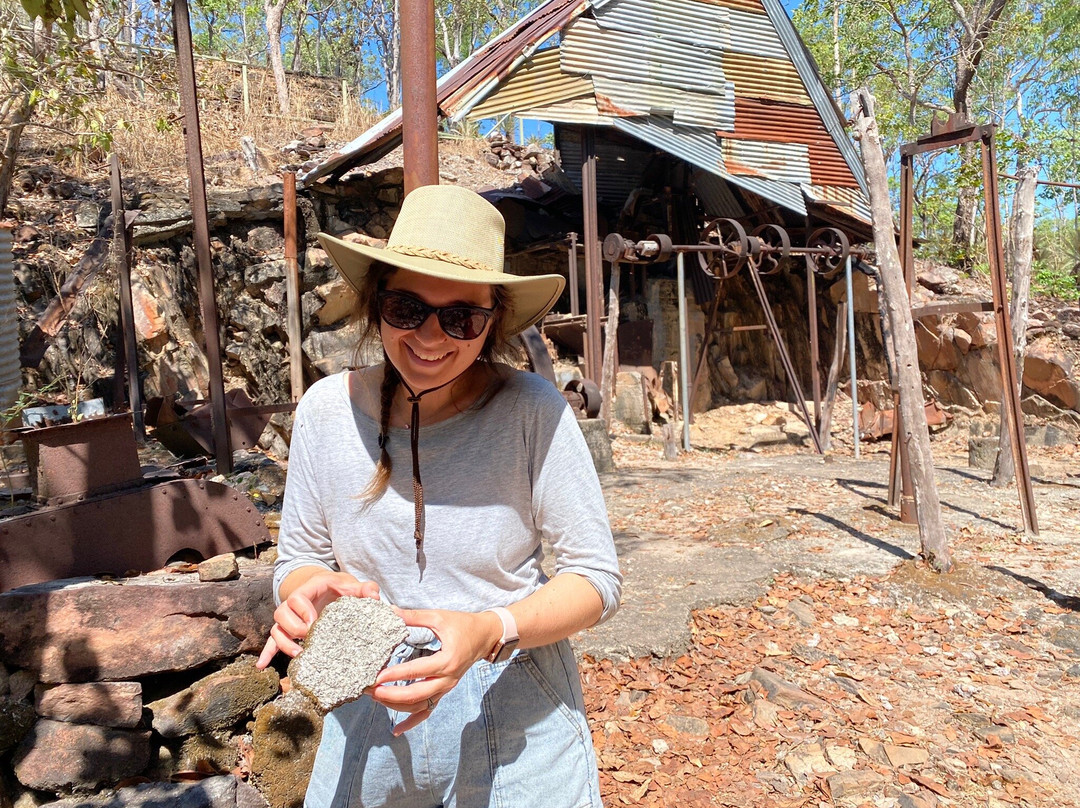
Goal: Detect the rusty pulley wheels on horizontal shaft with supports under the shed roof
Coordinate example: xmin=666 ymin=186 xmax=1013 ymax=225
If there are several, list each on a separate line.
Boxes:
xmin=604 ymin=218 xmax=856 ymax=453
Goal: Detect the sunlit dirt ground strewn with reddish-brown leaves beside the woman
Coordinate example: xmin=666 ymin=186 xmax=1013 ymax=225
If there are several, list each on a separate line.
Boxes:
xmin=578 ymin=441 xmax=1080 ymax=808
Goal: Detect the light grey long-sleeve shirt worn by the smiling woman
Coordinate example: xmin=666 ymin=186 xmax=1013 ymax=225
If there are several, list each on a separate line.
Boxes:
xmin=274 ymin=372 xmax=622 ymax=620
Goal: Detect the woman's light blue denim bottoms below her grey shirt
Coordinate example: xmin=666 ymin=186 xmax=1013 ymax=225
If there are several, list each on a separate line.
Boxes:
xmin=305 ymin=641 xmax=602 ymax=808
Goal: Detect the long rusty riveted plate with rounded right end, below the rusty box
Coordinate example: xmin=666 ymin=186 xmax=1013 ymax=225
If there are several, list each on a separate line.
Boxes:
xmin=0 ymin=480 xmax=270 ymax=592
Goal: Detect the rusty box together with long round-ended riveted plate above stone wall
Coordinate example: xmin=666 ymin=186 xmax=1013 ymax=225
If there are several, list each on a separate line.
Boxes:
xmin=0 ymin=413 xmax=270 ymax=592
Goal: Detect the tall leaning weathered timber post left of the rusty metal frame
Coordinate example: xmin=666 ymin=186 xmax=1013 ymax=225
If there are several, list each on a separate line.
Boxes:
xmin=855 ymin=87 xmax=953 ymax=573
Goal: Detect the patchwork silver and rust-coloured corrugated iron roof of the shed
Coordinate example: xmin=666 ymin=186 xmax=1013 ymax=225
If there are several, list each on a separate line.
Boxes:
xmin=301 ymin=0 xmax=868 ymax=220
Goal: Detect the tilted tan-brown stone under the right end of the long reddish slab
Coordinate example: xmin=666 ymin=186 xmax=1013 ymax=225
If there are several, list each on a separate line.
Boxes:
xmin=147 ymin=657 xmax=281 ymax=738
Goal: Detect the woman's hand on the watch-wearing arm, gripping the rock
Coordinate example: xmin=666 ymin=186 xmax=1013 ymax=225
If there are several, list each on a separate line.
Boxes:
xmin=369 ymin=609 xmax=502 ymax=735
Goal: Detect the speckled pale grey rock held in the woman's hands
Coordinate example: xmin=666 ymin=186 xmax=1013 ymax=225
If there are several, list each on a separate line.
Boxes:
xmin=288 ymin=597 xmax=408 ymax=713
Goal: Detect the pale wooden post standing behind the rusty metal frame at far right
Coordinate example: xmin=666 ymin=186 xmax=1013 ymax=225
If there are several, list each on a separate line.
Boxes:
xmin=990 ymin=160 xmax=1039 ymax=487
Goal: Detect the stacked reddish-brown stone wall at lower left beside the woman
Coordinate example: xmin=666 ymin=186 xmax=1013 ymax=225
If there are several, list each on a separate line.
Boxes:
xmin=0 ymin=552 xmax=322 ymax=808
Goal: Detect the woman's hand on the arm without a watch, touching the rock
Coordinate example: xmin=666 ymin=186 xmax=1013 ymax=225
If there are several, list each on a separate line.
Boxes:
xmin=255 ymin=568 xmax=379 ymax=671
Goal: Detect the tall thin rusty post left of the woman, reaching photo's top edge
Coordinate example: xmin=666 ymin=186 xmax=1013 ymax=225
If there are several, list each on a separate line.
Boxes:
xmin=173 ymin=0 xmax=232 ymax=474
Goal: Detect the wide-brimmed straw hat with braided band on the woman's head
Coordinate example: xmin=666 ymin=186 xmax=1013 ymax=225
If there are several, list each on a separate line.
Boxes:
xmin=319 ymin=185 xmax=566 ymax=335
